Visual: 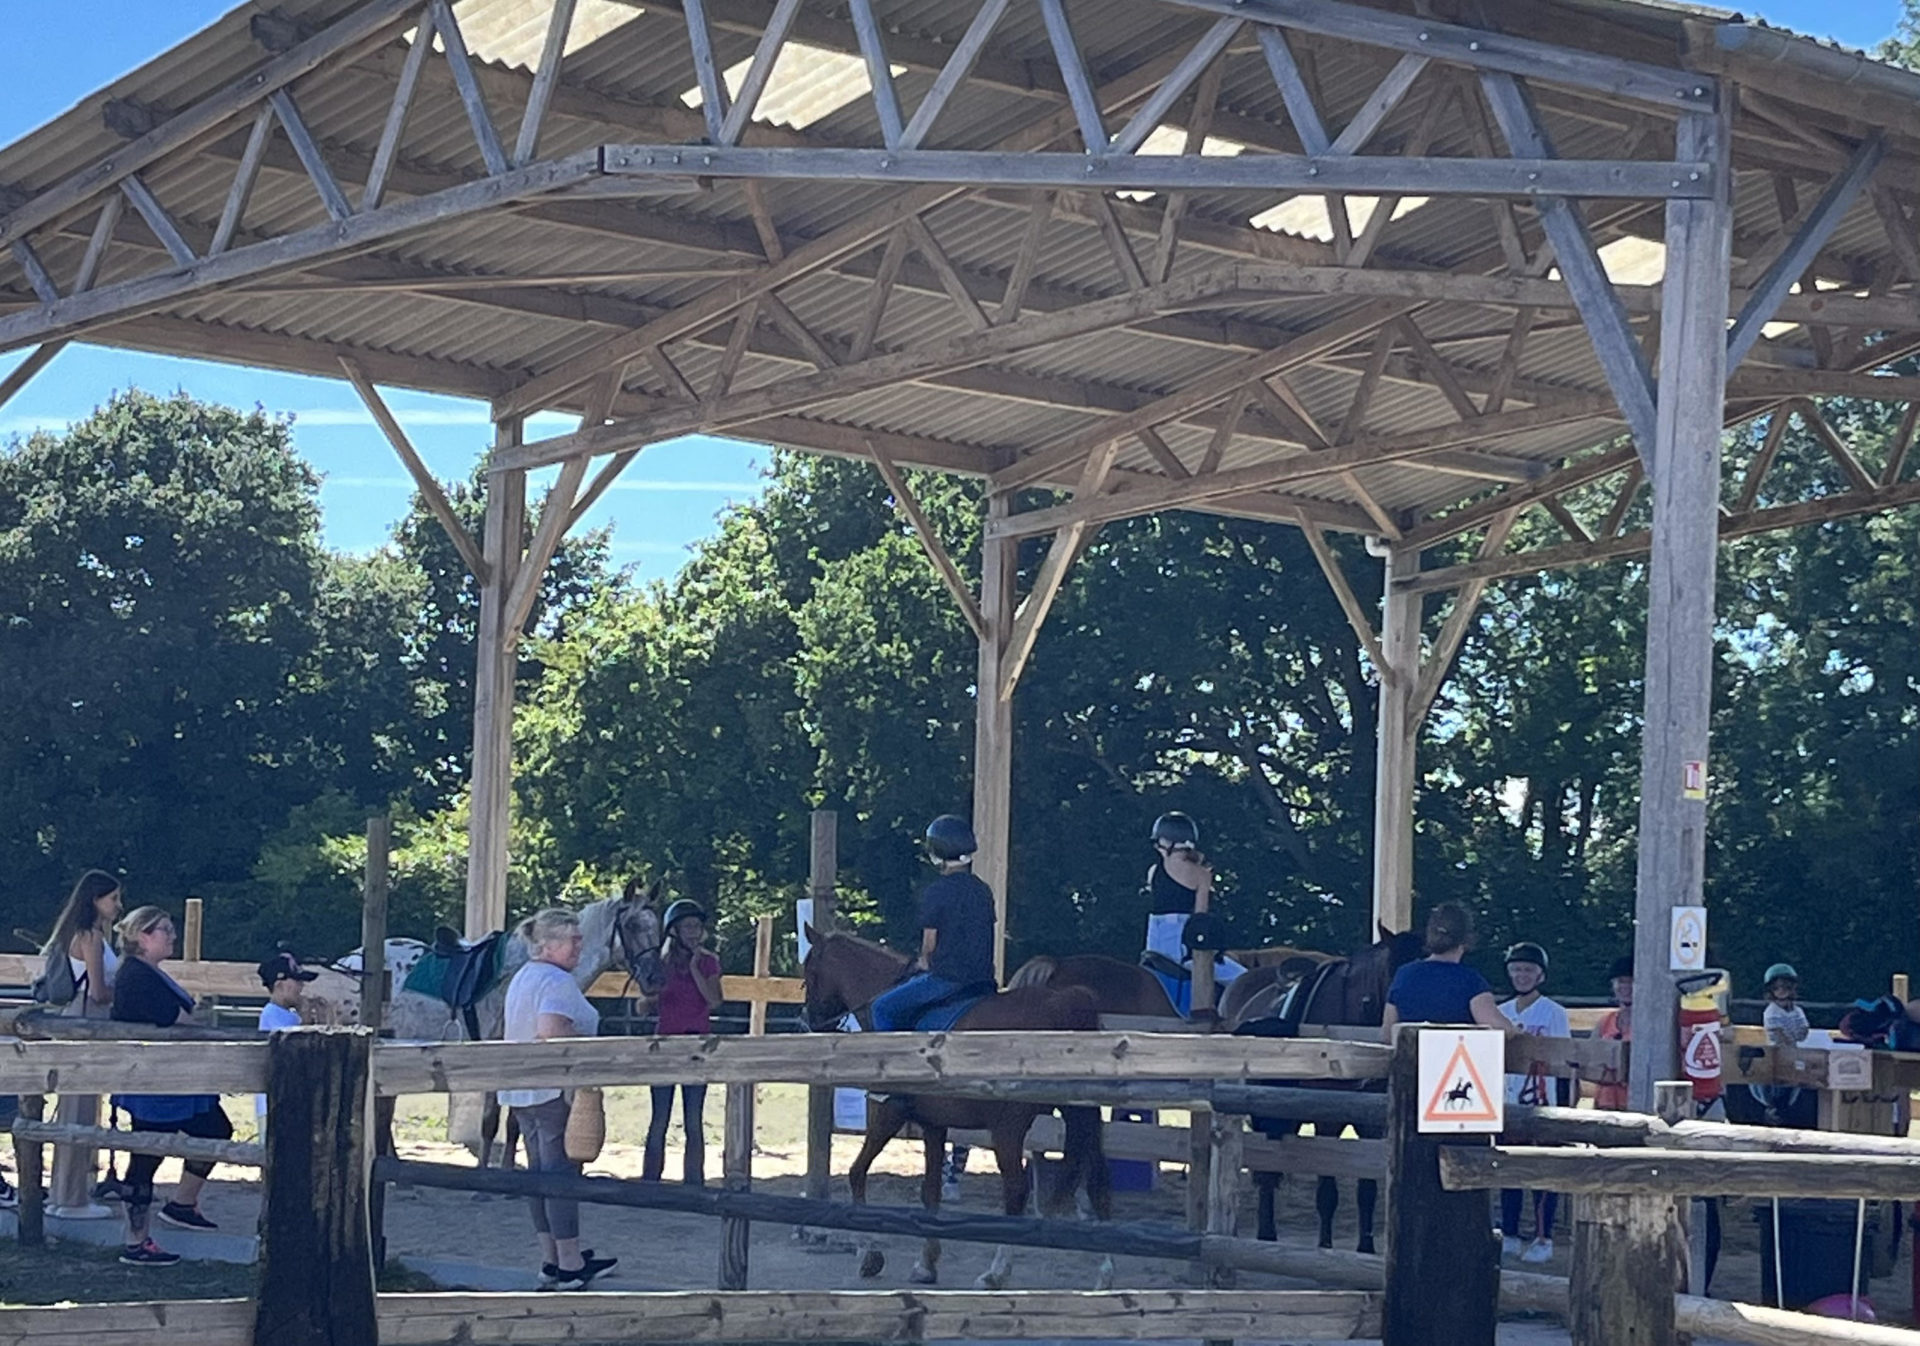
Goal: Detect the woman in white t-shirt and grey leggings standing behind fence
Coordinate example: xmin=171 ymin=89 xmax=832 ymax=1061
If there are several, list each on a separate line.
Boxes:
xmin=499 ymin=906 xmax=618 ymax=1290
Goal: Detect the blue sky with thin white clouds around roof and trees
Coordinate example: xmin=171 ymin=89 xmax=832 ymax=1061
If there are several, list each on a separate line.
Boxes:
xmin=0 ymin=0 xmax=1901 ymax=578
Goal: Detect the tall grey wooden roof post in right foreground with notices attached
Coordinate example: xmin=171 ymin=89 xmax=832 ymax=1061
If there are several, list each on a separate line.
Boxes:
xmin=1628 ymin=100 xmax=1734 ymax=1112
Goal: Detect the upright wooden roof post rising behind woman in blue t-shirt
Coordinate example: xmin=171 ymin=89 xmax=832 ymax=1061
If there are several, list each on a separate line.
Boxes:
xmin=1369 ymin=547 xmax=1421 ymax=933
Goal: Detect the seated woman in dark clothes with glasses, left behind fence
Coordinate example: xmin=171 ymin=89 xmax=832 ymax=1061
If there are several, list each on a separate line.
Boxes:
xmin=113 ymin=906 xmax=234 ymax=1265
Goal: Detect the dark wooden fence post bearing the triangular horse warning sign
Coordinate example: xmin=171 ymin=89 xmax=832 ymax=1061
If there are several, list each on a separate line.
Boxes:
xmin=1380 ymin=1025 xmax=1505 ymax=1346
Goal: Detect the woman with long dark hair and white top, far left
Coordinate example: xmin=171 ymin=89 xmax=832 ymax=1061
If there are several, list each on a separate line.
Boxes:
xmin=42 ymin=870 xmax=121 ymax=1219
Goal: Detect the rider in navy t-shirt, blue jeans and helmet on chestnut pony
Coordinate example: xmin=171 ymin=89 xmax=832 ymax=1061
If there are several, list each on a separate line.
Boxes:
xmin=870 ymin=814 xmax=995 ymax=1033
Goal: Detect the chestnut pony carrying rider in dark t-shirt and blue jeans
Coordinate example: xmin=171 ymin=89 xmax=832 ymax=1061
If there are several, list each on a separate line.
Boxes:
xmin=803 ymin=925 xmax=1121 ymax=1290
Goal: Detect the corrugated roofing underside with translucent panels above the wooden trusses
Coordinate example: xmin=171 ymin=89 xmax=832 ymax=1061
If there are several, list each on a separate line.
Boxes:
xmin=0 ymin=0 xmax=1920 ymax=528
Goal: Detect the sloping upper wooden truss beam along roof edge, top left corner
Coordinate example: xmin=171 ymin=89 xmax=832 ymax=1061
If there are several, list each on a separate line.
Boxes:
xmin=0 ymin=0 xmax=419 ymax=244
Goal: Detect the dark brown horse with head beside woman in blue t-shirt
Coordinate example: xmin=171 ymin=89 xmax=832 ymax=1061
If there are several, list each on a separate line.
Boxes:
xmin=1236 ymin=925 xmax=1421 ymax=1252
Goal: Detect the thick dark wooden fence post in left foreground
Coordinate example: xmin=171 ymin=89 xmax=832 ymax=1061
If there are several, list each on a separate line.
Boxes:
xmin=253 ymin=1029 xmax=380 ymax=1346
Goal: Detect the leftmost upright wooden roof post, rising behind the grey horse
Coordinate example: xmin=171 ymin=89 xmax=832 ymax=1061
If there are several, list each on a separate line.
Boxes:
xmin=467 ymin=417 xmax=526 ymax=939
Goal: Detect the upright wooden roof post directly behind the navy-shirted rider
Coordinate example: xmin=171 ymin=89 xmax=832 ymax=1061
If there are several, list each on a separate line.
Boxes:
xmin=973 ymin=492 xmax=1020 ymax=981
